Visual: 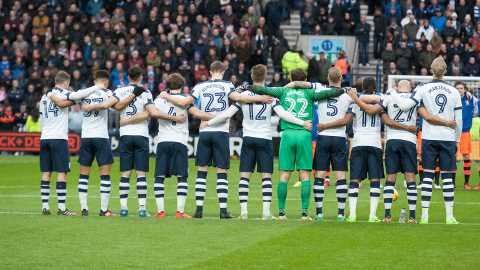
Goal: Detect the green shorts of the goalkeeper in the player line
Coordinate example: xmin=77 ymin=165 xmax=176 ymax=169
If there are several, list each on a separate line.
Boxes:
xmin=279 ymin=129 xmax=313 ymax=171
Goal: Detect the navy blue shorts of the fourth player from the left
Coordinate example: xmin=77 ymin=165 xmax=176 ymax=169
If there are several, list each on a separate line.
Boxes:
xmin=155 ymin=142 xmax=188 ymax=177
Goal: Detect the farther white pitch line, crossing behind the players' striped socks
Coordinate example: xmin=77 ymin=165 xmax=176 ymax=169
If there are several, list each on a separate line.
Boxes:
xmin=0 ymin=194 xmax=480 ymax=206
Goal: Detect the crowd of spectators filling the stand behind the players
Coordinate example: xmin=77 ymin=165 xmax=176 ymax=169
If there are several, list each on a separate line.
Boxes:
xmin=0 ymin=0 xmax=480 ymax=131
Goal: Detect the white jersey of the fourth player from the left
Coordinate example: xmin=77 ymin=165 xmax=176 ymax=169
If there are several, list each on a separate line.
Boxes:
xmin=154 ymin=94 xmax=188 ymax=146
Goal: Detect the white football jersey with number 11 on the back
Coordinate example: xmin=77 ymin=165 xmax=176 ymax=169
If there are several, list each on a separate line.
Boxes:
xmin=349 ymin=99 xmax=382 ymax=148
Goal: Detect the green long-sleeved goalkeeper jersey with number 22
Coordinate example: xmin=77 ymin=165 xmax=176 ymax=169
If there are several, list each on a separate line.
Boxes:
xmin=252 ymin=86 xmax=344 ymax=130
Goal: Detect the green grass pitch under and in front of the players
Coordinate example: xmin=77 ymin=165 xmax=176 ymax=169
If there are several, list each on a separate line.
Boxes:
xmin=0 ymin=157 xmax=480 ymax=269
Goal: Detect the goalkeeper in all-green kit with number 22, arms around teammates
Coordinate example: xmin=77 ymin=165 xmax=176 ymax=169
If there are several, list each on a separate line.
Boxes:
xmin=246 ymin=69 xmax=344 ymax=220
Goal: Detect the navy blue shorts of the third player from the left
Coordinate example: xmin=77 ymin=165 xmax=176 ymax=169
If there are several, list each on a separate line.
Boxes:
xmin=119 ymin=135 xmax=150 ymax=172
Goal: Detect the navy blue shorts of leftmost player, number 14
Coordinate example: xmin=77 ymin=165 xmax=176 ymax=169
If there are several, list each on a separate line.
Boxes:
xmin=40 ymin=139 xmax=70 ymax=172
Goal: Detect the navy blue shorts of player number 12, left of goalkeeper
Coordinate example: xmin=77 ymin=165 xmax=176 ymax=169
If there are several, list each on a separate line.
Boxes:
xmin=240 ymin=137 xmax=273 ymax=173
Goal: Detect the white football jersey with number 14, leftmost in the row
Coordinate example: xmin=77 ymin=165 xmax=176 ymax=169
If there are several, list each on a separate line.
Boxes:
xmin=39 ymin=87 xmax=69 ymax=140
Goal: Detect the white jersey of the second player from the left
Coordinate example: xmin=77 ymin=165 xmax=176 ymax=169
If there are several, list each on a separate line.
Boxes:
xmin=81 ymin=86 xmax=113 ymax=139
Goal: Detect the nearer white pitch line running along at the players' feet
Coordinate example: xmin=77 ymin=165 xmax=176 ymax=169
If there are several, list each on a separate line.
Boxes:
xmin=0 ymin=210 xmax=480 ymax=227
